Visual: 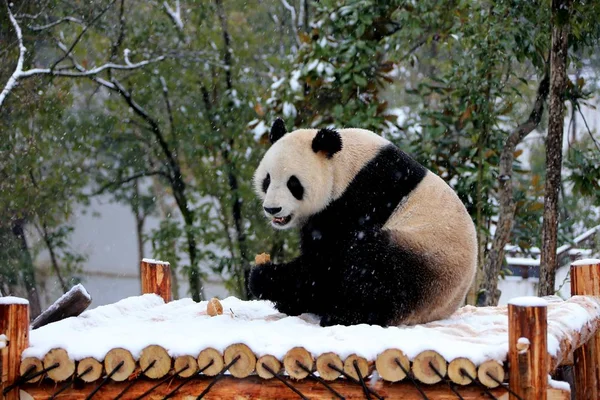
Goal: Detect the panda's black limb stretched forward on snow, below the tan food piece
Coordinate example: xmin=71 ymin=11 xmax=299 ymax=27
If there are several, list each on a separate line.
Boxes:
xmin=249 ymin=257 xmax=319 ymax=315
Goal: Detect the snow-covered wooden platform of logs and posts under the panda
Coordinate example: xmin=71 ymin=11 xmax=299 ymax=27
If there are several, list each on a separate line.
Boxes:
xmin=0 ymin=260 xmax=600 ymax=399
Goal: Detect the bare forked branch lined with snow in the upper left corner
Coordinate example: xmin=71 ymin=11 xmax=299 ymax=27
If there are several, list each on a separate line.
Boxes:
xmin=0 ymin=0 xmax=166 ymax=107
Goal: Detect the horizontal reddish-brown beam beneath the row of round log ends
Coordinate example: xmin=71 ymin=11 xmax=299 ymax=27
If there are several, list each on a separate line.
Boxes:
xmin=18 ymin=376 xmax=569 ymax=400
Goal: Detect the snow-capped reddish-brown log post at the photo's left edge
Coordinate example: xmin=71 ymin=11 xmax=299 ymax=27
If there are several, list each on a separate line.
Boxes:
xmin=0 ymin=297 xmax=29 ymax=400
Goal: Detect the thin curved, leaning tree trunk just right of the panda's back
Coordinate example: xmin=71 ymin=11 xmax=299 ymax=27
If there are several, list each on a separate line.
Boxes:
xmin=477 ymin=74 xmax=550 ymax=306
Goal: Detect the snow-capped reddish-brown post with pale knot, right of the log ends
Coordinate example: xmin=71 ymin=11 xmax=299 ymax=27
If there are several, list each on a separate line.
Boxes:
xmin=508 ymin=297 xmax=548 ymax=400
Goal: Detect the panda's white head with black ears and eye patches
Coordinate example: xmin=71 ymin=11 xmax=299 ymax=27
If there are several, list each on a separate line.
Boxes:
xmin=254 ymin=118 xmax=342 ymax=229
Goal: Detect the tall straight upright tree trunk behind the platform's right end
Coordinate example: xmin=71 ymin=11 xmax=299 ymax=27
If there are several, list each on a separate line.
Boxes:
xmin=538 ymin=0 xmax=571 ymax=296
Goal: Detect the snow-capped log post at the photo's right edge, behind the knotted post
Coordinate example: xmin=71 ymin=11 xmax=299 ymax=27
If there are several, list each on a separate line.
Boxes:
xmin=571 ymin=259 xmax=600 ymax=400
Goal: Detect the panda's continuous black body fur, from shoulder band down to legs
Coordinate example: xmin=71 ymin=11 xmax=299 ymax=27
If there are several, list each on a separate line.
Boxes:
xmin=250 ymin=144 xmax=435 ymax=325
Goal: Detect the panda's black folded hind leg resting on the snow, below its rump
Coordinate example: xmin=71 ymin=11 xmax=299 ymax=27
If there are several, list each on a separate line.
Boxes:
xmin=321 ymin=230 xmax=434 ymax=326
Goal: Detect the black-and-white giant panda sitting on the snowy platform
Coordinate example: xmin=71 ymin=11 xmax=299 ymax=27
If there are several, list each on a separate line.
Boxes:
xmin=249 ymin=119 xmax=477 ymax=326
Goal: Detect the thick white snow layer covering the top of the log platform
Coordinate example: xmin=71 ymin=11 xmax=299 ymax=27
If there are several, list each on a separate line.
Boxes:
xmin=23 ymin=294 xmax=600 ymax=364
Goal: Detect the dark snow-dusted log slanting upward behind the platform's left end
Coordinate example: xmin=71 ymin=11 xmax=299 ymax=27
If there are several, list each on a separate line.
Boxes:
xmin=31 ymin=283 xmax=92 ymax=329
